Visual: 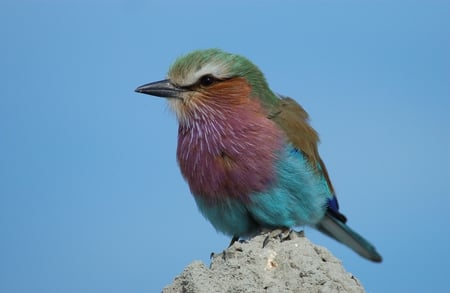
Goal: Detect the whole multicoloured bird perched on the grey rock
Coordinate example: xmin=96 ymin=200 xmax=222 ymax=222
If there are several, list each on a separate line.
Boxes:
xmin=135 ymin=48 xmax=382 ymax=262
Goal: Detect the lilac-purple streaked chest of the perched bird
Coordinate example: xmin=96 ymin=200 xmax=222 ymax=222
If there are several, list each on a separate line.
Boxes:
xmin=177 ymin=121 xmax=282 ymax=204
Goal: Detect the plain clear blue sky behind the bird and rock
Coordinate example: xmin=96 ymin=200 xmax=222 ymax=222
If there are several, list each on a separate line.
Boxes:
xmin=0 ymin=0 xmax=450 ymax=293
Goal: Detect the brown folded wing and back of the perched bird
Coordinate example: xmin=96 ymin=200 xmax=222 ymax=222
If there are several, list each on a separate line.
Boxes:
xmin=269 ymin=97 xmax=334 ymax=194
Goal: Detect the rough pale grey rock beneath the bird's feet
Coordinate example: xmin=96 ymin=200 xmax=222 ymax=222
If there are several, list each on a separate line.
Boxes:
xmin=163 ymin=233 xmax=364 ymax=293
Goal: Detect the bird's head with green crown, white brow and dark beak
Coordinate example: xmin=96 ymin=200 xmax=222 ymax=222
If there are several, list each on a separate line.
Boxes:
xmin=136 ymin=49 xmax=278 ymax=123
